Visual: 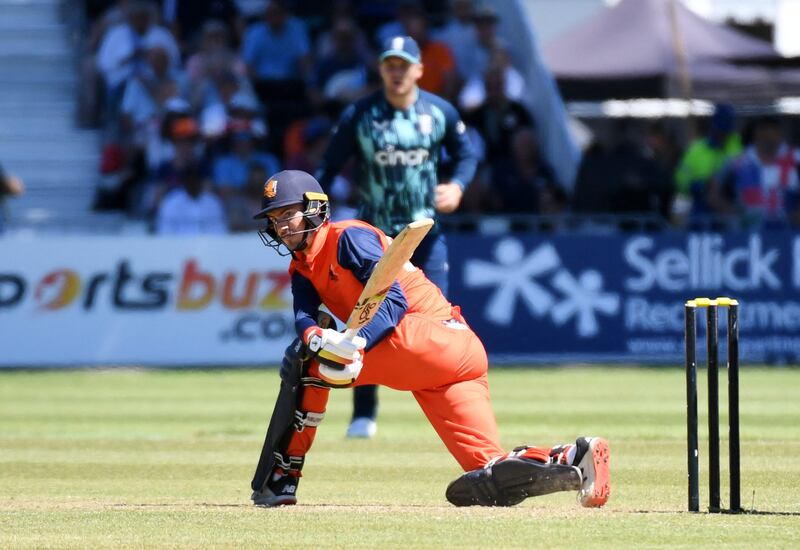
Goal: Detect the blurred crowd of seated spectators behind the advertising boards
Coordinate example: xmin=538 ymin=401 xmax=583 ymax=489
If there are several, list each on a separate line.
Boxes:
xmin=80 ymin=0 xmax=800 ymax=233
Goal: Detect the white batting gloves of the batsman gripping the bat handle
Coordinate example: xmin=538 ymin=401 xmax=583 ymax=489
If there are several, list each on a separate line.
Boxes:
xmin=303 ymin=326 xmax=367 ymax=386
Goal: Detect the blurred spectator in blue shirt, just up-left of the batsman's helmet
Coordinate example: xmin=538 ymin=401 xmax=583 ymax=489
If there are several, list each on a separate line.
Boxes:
xmin=214 ymin=130 xmax=280 ymax=199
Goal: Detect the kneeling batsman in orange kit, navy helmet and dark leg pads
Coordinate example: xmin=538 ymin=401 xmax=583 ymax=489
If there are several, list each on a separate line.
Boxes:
xmin=251 ymin=170 xmax=610 ymax=507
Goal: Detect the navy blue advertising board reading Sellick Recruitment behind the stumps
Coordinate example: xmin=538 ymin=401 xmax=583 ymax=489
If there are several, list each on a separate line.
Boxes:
xmin=448 ymin=232 xmax=800 ymax=364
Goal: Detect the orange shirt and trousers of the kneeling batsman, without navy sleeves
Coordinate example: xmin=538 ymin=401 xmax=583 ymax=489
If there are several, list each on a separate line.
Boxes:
xmin=289 ymin=220 xmax=503 ymax=470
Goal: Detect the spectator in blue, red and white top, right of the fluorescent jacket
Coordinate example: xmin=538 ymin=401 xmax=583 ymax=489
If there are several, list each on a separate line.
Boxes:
xmin=709 ymin=117 xmax=800 ymax=227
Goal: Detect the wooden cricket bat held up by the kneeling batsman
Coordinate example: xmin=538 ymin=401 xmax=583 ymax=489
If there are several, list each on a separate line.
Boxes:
xmin=344 ymin=218 xmax=433 ymax=340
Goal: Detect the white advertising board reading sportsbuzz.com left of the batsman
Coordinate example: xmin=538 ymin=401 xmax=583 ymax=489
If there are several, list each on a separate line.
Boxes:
xmin=0 ymin=235 xmax=294 ymax=366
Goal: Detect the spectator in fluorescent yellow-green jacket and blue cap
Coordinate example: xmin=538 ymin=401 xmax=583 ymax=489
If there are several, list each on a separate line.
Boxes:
xmin=672 ymin=104 xmax=742 ymax=225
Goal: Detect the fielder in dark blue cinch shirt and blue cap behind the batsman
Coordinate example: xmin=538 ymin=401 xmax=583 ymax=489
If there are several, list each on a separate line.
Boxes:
xmin=317 ymin=36 xmax=477 ymax=437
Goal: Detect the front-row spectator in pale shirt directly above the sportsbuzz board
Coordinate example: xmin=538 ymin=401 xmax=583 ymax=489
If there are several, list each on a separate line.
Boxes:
xmin=156 ymin=165 xmax=228 ymax=235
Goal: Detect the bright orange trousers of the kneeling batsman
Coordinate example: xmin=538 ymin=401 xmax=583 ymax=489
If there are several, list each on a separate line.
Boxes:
xmin=287 ymin=308 xmax=550 ymax=471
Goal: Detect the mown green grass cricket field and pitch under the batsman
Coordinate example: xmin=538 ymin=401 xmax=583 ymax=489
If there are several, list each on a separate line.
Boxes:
xmin=0 ymin=367 xmax=800 ymax=549
